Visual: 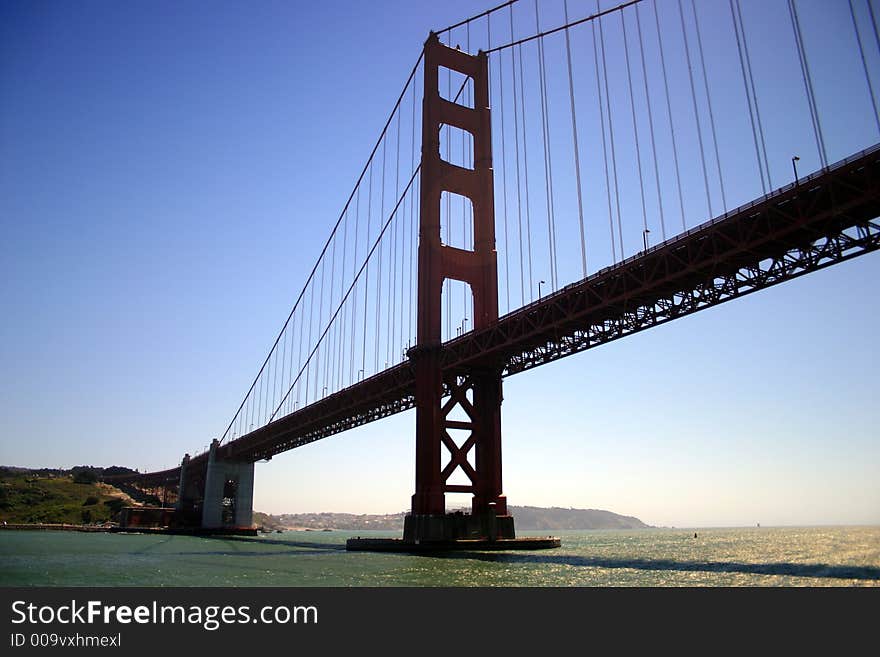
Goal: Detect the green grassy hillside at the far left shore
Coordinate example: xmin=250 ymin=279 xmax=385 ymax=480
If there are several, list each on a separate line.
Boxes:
xmin=0 ymin=466 xmax=132 ymax=524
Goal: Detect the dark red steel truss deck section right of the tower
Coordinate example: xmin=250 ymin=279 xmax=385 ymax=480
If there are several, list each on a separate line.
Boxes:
xmin=443 ymin=149 xmax=880 ymax=376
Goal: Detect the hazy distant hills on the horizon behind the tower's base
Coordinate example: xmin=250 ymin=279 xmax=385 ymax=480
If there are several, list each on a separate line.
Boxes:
xmin=254 ymin=506 xmax=649 ymax=531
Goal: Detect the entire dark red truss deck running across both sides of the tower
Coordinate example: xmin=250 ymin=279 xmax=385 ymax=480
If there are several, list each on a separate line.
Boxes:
xmin=115 ymin=146 xmax=880 ymax=485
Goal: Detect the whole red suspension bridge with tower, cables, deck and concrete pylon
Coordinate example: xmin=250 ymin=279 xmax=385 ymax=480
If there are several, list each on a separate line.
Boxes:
xmin=108 ymin=0 xmax=880 ymax=545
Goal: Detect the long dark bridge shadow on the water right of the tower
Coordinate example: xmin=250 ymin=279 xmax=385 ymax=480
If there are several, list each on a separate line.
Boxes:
xmin=425 ymin=552 xmax=880 ymax=581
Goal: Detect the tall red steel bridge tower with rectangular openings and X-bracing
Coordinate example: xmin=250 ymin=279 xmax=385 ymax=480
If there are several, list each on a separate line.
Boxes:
xmin=404 ymin=33 xmax=514 ymax=542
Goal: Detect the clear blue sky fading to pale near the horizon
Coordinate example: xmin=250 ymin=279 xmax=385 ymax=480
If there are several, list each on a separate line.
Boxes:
xmin=0 ymin=0 xmax=880 ymax=526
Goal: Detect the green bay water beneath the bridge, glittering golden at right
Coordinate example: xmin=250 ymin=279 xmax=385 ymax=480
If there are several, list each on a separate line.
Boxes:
xmin=0 ymin=526 xmax=880 ymax=587
